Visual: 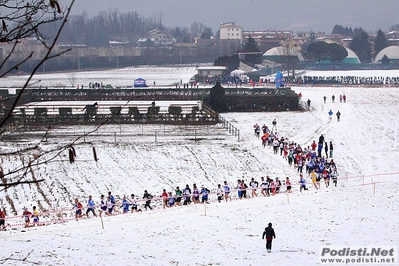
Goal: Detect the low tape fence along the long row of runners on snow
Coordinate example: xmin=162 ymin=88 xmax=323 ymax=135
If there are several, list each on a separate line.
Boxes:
xmin=5 ymin=173 xmax=398 ymax=231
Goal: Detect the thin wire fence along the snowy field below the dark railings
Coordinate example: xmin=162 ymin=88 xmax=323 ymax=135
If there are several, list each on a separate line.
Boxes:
xmin=0 ymin=124 xmax=239 ymax=147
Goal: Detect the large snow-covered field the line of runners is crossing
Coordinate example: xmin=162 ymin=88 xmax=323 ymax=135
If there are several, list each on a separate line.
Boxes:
xmin=0 ymin=69 xmax=399 ymax=265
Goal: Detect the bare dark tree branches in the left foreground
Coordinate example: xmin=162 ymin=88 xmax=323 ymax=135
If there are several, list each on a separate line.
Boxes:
xmin=0 ymin=0 xmax=75 ymax=189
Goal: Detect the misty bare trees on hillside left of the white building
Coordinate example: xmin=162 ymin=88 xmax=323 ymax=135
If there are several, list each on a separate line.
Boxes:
xmin=40 ymin=9 xmax=213 ymax=47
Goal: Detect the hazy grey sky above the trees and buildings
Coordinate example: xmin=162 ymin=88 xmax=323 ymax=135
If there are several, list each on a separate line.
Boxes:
xmin=73 ymin=0 xmax=399 ymax=33
